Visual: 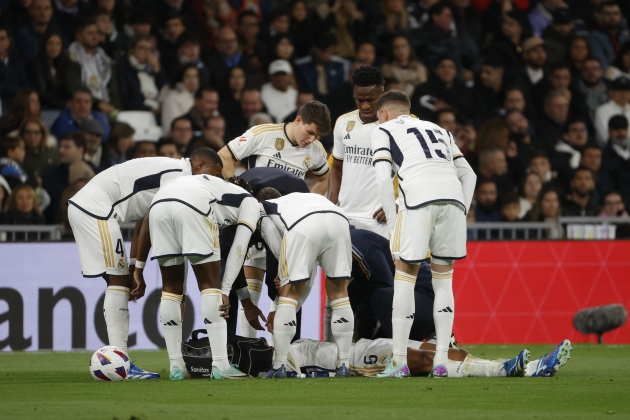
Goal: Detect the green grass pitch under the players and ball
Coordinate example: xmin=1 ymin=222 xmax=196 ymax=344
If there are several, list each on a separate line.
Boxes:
xmin=0 ymin=345 xmax=630 ymax=420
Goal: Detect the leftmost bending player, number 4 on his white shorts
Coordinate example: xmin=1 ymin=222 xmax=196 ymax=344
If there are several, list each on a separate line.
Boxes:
xmin=68 ymin=148 xmax=222 ymax=379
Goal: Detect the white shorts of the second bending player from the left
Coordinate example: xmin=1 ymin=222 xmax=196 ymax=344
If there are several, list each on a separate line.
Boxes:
xmin=149 ymin=201 xmax=221 ymax=266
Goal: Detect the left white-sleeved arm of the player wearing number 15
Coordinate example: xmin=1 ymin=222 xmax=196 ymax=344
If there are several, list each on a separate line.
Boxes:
xmin=372 ymin=128 xmax=396 ymax=234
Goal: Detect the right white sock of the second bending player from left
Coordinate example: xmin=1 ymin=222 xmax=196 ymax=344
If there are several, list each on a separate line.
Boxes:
xmin=201 ymin=289 xmax=230 ymax=372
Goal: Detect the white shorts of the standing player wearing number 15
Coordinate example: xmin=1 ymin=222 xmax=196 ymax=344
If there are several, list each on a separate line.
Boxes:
xmin=390 ymin=203 xmax=466 ymax=264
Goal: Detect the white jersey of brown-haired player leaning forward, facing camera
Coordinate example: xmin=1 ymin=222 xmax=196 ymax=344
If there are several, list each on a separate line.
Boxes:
xmin=227 ymin=124 xmax=329 ymax=179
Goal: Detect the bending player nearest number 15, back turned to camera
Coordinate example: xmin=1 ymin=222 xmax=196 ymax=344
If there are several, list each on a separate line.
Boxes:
xmin=261 ymin=193 xmax=354 ymax=378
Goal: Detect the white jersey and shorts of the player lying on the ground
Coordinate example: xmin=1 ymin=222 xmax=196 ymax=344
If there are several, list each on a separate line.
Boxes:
xmin=287 ymin=338 xmax=422 ymax=376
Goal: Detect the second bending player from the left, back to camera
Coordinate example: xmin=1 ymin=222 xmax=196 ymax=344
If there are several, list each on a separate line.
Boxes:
xmin=135 ymin=175 xmax=260 ymax=380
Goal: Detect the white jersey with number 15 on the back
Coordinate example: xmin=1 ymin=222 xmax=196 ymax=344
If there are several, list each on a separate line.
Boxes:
xmin=372 ymin=115 xmax=466 ymax=211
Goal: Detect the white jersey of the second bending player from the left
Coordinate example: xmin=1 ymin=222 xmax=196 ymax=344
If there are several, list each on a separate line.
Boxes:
xmin=151 ymin=175 xmax=260 ymax=232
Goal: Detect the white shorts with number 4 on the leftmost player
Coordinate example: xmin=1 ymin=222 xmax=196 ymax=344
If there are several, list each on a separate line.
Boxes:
xmin=68 ymin=204 xmax=129 ymax=277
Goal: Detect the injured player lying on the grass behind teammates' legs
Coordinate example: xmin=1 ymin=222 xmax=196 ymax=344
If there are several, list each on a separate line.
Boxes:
xmin=287 ymin=338 xmax=572 ymax=378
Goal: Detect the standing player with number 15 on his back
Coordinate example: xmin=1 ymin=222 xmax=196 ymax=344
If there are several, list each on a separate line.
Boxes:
xmin=372 ymin=90 xmax=477 ymax=377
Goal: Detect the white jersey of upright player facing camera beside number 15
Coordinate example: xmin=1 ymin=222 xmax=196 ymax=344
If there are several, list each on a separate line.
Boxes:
xmin=333 ymin=110 xmax=381 ymax=219
